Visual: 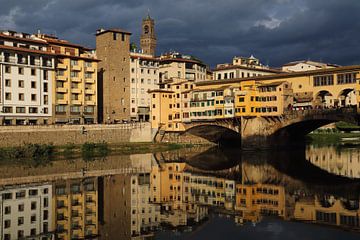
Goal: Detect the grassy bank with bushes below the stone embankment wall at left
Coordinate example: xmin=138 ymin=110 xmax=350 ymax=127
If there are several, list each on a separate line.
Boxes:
xmin=0 ymin=142 xmax=198 ymax=166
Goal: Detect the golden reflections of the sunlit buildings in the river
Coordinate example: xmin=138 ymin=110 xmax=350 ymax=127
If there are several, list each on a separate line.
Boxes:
xmin=0 ymin=145 xmax=360 ymax=239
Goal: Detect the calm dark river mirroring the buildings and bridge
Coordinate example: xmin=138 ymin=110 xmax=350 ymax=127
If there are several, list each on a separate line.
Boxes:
xmin=0 ymin=143 xmax=360 ymax=240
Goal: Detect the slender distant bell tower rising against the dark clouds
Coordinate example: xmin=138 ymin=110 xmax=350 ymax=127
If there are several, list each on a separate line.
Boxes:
xmin=140 ymin=14 xmax=156 ymax=56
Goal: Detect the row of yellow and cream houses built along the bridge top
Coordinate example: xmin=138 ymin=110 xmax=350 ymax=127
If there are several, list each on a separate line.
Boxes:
xmin=153 ymin=66 xmax=360 ymax=131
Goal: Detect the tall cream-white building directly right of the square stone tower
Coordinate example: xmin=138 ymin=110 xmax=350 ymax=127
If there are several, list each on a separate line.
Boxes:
xmin=130 ymin=52 xmax=159 ymax=121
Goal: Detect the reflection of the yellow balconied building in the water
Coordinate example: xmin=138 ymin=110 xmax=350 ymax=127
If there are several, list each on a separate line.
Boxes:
xmin=53 ymin=178 xmax=98 ymax=240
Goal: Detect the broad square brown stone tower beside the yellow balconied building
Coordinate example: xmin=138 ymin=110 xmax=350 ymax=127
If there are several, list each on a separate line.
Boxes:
xmin=96 ymin=29 xmax=131 ymax=123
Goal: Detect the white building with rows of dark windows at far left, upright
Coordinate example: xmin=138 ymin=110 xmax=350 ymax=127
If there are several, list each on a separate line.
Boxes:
xmin=0 ymin=31 xmax=55 ymax=125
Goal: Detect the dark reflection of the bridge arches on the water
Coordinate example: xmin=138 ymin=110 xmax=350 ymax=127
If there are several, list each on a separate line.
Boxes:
xmin=184 ymin=146 xmax=360 ymax=195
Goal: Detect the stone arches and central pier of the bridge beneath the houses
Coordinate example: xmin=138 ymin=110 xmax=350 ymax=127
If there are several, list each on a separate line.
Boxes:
xmin=184 ymin=108 xmax=360 ymax=149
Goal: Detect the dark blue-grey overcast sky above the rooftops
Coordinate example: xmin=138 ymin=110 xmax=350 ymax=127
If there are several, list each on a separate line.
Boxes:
xmin=0 ymin=0 xmax=360 ymax=67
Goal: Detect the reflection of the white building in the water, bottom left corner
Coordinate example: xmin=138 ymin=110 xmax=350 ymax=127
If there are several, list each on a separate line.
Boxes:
xmin=0 ymin=184 xmax=53 ymax=240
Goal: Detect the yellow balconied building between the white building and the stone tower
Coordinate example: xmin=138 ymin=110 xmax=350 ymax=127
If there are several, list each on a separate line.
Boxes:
xmin=37 ymin=34 xmax=98 ymax=123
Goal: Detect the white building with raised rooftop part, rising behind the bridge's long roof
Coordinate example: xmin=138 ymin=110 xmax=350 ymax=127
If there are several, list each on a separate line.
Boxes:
xmin=213 ymin=56 xmax=281 ymax=80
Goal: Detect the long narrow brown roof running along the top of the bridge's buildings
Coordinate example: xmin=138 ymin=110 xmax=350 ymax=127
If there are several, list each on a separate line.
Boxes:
xmin=195 ymin=65 xmax=360 ymax=86
